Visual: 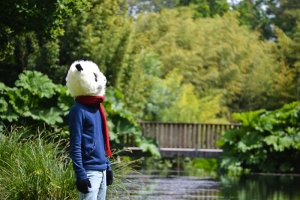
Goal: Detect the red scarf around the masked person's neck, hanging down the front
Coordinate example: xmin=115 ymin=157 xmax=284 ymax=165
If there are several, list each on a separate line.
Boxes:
xmin=76 ymin=96 xmax=112 ymax=157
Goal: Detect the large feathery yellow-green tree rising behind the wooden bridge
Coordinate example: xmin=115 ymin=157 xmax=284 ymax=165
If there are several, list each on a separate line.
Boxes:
xmin=125 ymin=7 xmax=280 ymax=116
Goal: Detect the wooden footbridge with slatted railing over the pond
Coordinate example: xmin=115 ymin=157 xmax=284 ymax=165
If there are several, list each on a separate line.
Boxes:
xmin=123 ymin=122 xmax=240 ymax=158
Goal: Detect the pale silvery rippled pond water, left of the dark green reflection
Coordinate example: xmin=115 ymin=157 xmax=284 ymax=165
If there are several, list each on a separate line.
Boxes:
xmin=128 ymin=175 xmax=219 ymax=200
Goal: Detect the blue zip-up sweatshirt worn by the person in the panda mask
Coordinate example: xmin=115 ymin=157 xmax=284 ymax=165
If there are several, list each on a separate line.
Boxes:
xmin=69 ymin=102 xmax=110 ymax=181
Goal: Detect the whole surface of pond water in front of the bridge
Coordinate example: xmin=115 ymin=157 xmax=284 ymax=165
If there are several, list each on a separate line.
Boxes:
xmin=124 ymin=172 xmax=300 ymax=200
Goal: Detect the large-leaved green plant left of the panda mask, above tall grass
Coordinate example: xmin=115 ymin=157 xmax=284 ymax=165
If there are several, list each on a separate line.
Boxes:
xmin=0 ymin=71 xmax=64 ymax=125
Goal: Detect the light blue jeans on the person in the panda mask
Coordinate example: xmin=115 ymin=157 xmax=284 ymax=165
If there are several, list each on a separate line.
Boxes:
xmin=79 ymin=170 xmax=106 ymax=200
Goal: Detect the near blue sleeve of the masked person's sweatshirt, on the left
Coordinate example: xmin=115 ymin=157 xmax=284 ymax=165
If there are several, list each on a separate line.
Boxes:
xmin=69 ymin=106 xmax=87 ymax=181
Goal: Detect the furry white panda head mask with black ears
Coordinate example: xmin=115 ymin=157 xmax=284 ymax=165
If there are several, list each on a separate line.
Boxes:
xmin=66 ymin=60 xmax=106 ymax=97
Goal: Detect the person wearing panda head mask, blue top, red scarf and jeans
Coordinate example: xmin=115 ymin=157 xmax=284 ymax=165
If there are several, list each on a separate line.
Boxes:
xmin=66 ymin=61 xmax=113 ymax=200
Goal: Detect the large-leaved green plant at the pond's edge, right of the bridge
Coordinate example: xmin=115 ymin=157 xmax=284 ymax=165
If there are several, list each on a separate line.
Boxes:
xmin=221 ymin=102 xmax=300 ymax=174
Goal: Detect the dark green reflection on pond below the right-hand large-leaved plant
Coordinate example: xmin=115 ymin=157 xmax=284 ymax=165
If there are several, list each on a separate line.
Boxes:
xmin=219 ymin=175 xmax=300 ymax=200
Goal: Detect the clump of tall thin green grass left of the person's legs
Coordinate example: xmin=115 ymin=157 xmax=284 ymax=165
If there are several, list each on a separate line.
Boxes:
xmin=0 ymin=129 xmax=77 ymax=200
